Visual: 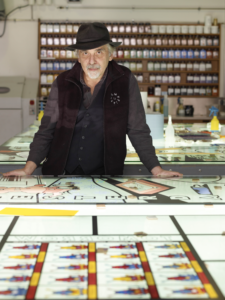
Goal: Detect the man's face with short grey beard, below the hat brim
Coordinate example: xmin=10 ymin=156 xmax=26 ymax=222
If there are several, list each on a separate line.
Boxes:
xmin=78 ymin=45 xmax=113 ymax=79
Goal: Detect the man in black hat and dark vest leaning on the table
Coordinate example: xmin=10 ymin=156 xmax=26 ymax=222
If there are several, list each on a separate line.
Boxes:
xmin=5 ymin=23 xmax=180 ymax=176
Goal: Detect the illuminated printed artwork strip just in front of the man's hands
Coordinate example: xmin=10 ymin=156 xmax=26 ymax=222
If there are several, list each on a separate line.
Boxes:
xmin=0 ymin=176 xmax=225 ymax=204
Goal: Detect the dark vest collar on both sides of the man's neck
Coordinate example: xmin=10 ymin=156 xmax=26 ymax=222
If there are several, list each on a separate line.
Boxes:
xmin=65 ymin=60 xmax=124 ymax=86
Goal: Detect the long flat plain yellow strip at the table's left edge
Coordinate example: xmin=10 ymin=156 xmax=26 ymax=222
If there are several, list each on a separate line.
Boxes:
xmin=0 ymin=207 xmax=78 ymax=217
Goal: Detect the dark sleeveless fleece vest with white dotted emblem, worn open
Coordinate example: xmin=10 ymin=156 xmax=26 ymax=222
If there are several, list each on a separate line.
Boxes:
xmin=42 ymin=61 xmax=130 ymax=175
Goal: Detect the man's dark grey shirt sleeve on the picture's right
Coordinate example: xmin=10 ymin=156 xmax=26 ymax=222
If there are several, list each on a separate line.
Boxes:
xmin=127 ymin=73 xmax=160 ymax=172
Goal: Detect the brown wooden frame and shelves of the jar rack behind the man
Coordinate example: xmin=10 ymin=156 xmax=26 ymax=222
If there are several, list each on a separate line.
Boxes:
xmin=38 ymin=21 xmax=221 ymax=102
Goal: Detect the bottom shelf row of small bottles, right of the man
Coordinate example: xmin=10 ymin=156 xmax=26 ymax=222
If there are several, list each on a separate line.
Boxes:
xmin=148 ymin=85 xmax=218 ymax=97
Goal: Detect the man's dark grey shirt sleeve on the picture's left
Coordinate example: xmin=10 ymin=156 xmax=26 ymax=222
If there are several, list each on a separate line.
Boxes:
xmin=27 ymin=79 xmax=59 ymax=166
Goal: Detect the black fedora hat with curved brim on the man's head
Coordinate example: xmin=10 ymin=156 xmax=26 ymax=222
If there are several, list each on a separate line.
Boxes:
xmin=66 ymin=22 xmax=121 ymax=50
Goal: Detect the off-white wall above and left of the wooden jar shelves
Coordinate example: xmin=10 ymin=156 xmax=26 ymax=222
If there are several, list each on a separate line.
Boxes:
xmin=0 ymin=0 xmax=225 ymax=89
